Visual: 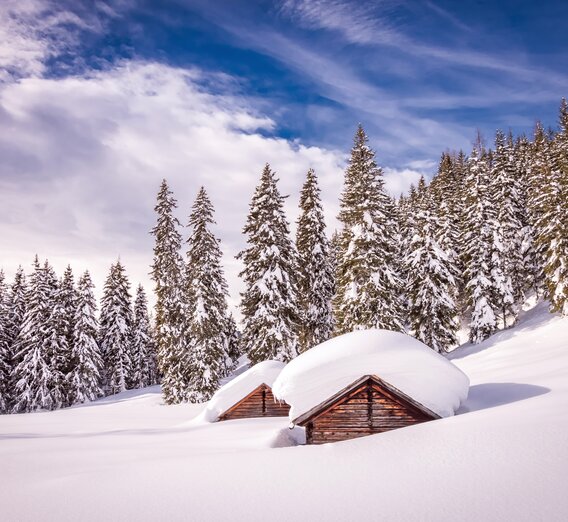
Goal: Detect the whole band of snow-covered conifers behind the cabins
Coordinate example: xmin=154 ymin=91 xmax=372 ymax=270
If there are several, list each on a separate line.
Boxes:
xmin=0 ymin=99 xmax=568 ymax=413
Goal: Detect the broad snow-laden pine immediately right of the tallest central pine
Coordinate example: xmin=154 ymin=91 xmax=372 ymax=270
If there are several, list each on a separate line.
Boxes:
xmin=405 ymin=187 xmax=459 ymax=352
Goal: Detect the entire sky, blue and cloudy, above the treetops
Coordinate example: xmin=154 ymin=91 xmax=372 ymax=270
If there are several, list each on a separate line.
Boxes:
xmin=0 ymin=0 xmax=568 ymax=303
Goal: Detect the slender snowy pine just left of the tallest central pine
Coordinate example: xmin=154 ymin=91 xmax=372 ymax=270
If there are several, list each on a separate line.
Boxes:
xmin=296 ymin=169 xmax=334 ymax=352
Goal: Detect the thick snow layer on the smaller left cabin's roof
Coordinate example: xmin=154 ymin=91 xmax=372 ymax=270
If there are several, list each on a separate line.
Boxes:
xmin=203 ymin=361 xmax=285 ymax=422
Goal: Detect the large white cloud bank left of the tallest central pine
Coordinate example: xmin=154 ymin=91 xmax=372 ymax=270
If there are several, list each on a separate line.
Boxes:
xmin=0 ymin=63 xmax=344 ymax=312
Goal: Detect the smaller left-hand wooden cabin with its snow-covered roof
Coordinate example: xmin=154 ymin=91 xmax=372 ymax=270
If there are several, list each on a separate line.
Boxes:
xmin=205 ymin=361 xmax=290 ymax=422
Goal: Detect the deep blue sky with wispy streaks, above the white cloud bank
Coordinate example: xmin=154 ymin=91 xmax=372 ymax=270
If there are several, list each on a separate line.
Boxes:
xmin=35 ymin=0 xmax=568 ymax=162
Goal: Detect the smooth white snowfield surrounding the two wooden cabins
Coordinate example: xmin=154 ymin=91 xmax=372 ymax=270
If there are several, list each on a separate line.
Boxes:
xmin=0 ymin=305 xmax=568 ymax=522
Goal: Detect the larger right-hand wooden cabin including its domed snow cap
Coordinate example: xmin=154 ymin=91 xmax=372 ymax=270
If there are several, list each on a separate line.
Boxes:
xmin=273 ymin=330 xmax=469 ymax=444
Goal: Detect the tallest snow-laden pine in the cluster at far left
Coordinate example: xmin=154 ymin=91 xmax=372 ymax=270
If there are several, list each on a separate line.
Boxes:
xmin=12 ymin=256 xmax=63 ymax=412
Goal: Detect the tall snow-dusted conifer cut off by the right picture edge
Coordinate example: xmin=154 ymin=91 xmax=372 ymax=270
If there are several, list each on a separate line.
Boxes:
xmin=543 ymin=98 xmax=568 ymax=315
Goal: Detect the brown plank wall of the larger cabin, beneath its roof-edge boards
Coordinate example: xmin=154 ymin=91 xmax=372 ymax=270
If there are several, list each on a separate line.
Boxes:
xmin=306 ymin=382 xmax=431 ymax=444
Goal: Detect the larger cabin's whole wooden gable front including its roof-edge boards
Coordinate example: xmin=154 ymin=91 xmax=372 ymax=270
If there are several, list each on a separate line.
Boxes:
xmin=294 ymin=375 xmax=439 ymax=444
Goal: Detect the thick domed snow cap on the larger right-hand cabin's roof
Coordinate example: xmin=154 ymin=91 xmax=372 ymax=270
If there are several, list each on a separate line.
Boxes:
xmin=272 ymin=330 xmax=469 ymax=420
